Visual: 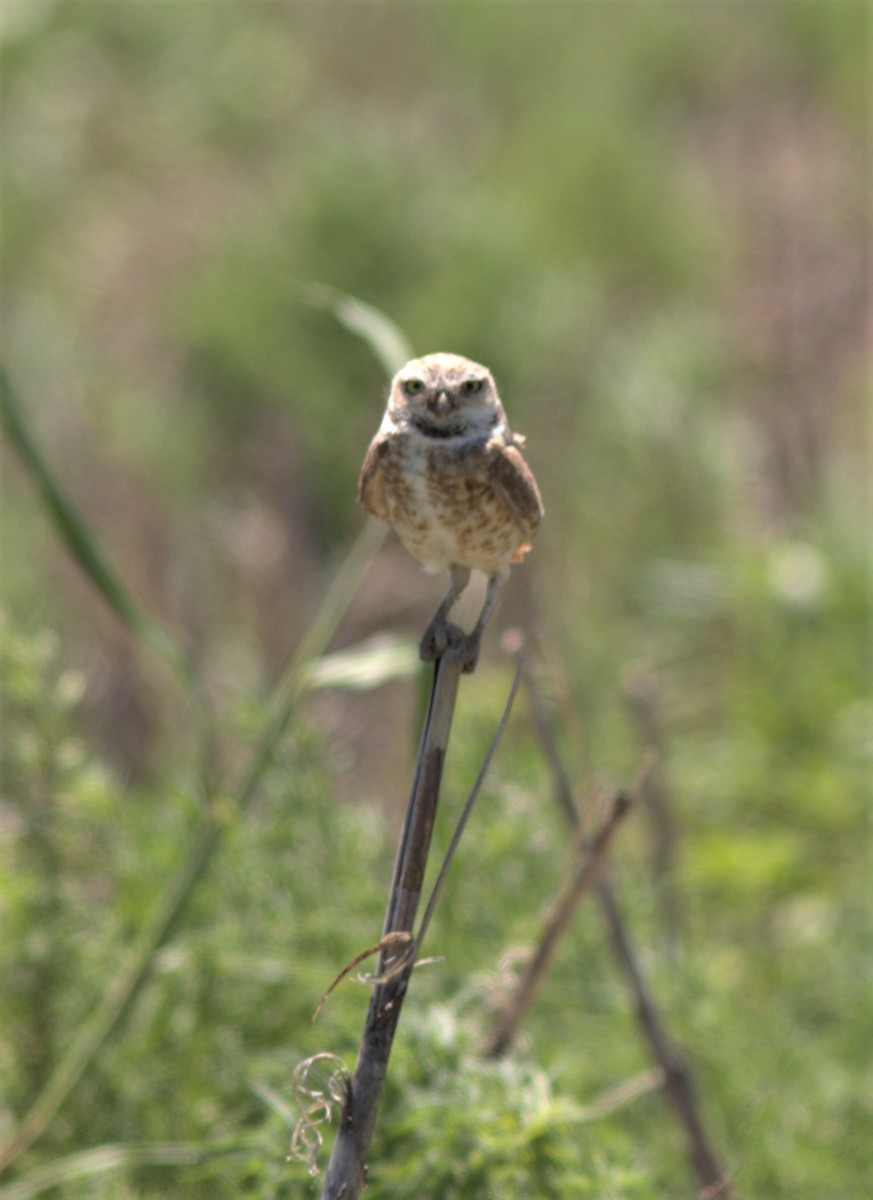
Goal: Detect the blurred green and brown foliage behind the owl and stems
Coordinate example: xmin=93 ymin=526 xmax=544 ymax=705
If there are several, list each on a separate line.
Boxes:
xmin=0 ymin=0 xmax=873 ymax=1200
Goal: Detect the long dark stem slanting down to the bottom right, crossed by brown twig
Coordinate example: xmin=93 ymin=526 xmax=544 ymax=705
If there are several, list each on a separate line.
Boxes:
xmin=524 ymin=671 xmax=733 ymax=1200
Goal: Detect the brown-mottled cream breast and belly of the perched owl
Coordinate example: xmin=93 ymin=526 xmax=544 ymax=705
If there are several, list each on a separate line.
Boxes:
xmin=381 ymin=433 xmax=529 ymax=572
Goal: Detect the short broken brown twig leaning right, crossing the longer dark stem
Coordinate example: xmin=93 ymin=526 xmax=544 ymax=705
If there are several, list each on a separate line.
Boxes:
xmin=484 ymin=792 xmax=632 ymax=1057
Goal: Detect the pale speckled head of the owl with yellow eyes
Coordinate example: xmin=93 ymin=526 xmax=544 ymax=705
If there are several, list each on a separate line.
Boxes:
xmin=386 ymin=354 xmax=506 ymax=438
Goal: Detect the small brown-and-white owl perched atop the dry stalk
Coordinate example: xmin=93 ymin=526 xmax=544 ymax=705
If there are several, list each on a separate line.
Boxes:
xmin=357 ymin=354 xmax=543 ymax=671
